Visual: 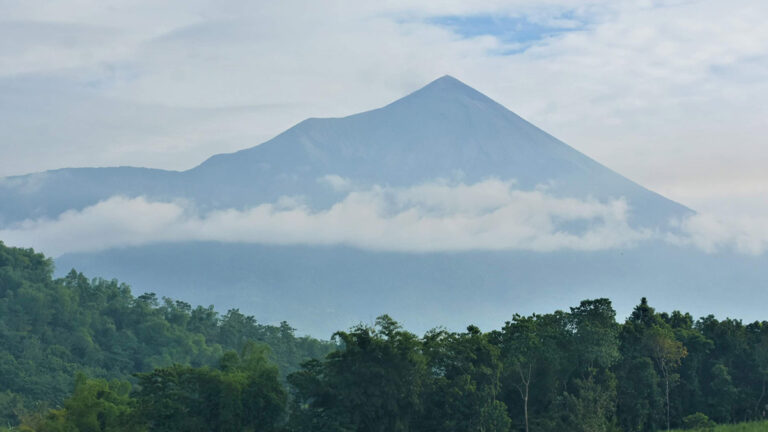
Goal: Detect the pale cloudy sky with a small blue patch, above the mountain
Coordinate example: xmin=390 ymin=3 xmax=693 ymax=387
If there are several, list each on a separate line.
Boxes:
xmin=0 ymin=0 xmax=768 ymax=226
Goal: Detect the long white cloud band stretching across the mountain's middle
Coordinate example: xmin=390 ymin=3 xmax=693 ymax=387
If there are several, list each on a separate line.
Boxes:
xmin=0 ymin=180 xmax=650 ymax=256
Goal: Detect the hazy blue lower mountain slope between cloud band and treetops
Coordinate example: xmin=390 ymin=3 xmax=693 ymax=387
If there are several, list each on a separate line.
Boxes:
xmin=56 ymin=242 xmax=768 ymax=338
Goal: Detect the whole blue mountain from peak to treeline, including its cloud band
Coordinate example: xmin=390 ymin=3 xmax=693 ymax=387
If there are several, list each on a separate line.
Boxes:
xmin=0 ymin=76 xmax=768 ymax=335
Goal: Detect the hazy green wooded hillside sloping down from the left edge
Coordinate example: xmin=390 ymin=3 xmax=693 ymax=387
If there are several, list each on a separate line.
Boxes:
xmin=0 ymin=242 xmax=336 ymax=425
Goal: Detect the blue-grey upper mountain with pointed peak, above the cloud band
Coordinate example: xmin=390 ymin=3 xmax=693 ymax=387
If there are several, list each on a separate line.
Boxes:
xmin=0 ymin=76 xmax=690 ymax=227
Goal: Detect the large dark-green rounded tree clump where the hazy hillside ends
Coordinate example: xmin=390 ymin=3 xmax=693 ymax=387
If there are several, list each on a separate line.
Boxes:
xmin=288 ymin=315 xmax=427 ymax=432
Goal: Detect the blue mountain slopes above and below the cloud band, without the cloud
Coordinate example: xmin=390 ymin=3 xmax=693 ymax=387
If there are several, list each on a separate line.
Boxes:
xmin=0 ymin=76 xmax=768 ymax=336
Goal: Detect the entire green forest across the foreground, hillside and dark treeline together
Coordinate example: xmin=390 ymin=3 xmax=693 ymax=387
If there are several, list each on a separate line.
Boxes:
xmin=0 ymin=243 xmax=768 ymax=432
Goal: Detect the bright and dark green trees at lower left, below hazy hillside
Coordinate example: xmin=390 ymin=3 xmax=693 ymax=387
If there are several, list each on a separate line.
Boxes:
xmin=14 ymin=343 xmax=286 ymax=432
